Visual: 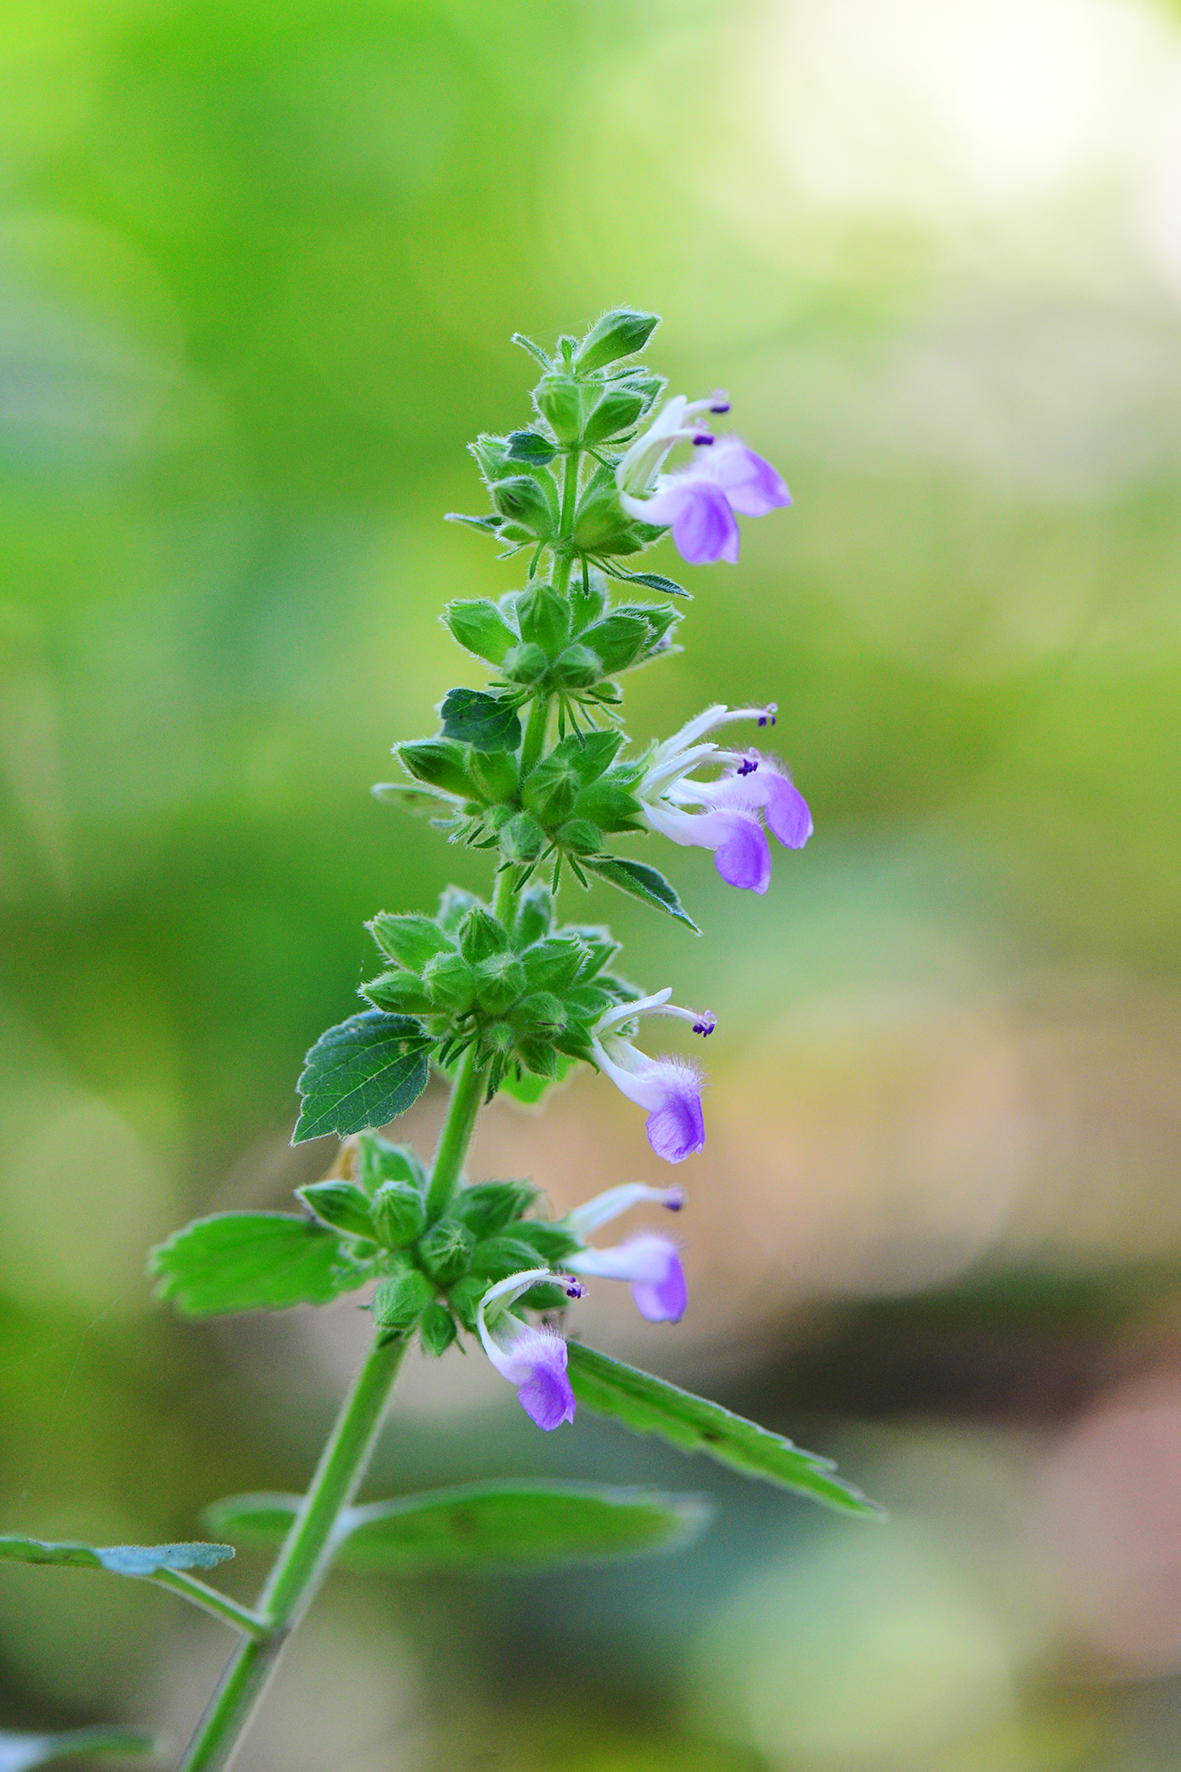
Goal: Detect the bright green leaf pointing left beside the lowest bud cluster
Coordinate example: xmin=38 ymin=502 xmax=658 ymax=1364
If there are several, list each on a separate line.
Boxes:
xmin=147 ymin=1212 xmax=349 ymax=1317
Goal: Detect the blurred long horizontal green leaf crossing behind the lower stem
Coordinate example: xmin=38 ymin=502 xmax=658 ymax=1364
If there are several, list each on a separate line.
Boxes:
xmin=204 ymin=1478 xmax=711 ymax=1575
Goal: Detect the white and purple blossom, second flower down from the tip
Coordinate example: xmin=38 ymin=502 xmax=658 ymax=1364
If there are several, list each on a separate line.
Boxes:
xmin=637 ymin=702 xmax=812 ymax=893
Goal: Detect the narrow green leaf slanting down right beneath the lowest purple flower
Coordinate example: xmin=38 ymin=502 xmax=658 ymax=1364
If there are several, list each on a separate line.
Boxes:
xmin=567 ymin=1341 xmax=881 ymax=1517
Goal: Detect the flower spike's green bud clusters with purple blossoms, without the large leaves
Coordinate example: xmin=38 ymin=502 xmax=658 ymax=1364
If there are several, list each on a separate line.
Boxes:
xmin=358 ymin=308 xmax=812 ymax=1428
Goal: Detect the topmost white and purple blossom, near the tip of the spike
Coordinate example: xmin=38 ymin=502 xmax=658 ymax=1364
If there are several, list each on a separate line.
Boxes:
xmin=615 ymin=392 xmax=791 ymax=565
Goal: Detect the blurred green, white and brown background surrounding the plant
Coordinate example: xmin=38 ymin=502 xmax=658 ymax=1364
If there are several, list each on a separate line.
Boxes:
xmin=0 ymin=0 xmax=1181 ymax=1772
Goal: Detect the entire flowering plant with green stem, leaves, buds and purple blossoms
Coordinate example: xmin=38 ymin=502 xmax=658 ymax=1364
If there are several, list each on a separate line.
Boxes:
xmin=0 ymin=308 xmax=876 ymax=1772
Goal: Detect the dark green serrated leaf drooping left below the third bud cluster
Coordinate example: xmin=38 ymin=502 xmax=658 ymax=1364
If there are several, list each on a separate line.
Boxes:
xmin=291 ymin=1008 xmax=431 ymax=1145
